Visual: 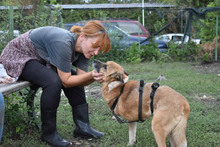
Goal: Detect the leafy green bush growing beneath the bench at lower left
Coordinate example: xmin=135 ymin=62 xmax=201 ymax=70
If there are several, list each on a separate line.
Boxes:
xmin=4 ymin=90 xmax=36 ymax=139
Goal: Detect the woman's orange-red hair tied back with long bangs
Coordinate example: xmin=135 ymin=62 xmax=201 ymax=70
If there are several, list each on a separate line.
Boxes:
xmin=70 ymin=20 xmax=111 ymax=53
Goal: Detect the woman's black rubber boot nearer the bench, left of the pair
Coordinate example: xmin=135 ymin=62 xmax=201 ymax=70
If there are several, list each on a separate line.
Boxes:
xmin=41 ymin=111 xmax=70 ymax=147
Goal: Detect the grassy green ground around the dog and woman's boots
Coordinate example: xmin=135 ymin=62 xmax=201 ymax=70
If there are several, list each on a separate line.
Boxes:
xmin=0 ymin=63 xmax=220 ymax=147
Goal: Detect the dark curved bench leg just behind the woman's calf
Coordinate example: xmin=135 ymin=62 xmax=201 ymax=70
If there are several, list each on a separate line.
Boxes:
xmin=27 ymin=86 xmax=41 ymax=129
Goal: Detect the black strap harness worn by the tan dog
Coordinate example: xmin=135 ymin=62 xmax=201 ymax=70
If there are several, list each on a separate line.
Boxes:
xmin=111 ymin=80 xmax=159 ymax=124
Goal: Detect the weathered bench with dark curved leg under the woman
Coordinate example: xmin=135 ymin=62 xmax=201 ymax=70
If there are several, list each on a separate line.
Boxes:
xmin=0 ymin=81 xmax=41 ymax=129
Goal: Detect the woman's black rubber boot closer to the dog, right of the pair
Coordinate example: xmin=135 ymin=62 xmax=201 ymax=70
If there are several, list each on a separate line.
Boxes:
xmin=73 ymin=103 xmax=104 ymax=138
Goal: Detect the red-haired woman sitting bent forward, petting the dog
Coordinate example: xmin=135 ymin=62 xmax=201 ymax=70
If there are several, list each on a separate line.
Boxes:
xmin=0 ymin=20 xmax=111 ymax=146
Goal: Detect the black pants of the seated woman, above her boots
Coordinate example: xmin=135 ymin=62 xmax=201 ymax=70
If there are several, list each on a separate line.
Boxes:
xmin=19 ymin=60 xmax=86 ymax=111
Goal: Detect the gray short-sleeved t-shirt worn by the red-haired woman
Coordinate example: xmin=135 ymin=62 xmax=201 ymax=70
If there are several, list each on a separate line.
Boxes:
xmin=30 ymin=26 xmax=89 ymax=72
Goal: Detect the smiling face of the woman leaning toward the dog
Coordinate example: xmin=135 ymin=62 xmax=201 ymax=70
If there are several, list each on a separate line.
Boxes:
xmin=81 ymin=36 xmax=99 ymax=59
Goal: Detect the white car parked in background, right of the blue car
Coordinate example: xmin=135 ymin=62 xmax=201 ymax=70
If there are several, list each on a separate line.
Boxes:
xmin=155 ymin=33 xmax=201 ymax=44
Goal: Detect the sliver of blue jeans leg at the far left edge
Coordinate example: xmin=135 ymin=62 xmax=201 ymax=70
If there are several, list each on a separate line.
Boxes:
xmin=0 ymin=92 xmax=5 ymax=144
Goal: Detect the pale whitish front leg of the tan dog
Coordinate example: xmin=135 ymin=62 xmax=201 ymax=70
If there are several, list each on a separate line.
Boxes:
xmin=128 ymin=122 xmax=137 ymax=146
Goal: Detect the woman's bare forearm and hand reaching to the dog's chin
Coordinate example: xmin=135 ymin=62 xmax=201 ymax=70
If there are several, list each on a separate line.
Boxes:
xmin=57 ymin=68 xmax=104 ymax=88
